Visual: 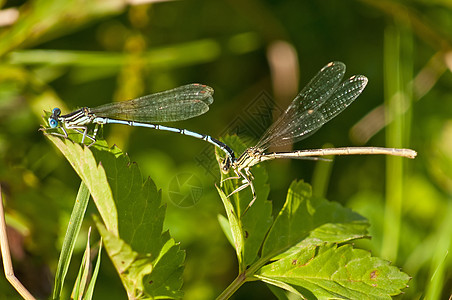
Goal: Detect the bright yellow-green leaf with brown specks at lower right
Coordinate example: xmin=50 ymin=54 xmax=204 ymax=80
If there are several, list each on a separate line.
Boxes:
xmin=256 ymin=244 xmax=410 ymax=299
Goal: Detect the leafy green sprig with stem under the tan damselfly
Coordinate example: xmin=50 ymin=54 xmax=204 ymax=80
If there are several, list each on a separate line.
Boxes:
xmin=215 ymin=138 xmax=409 ymax=299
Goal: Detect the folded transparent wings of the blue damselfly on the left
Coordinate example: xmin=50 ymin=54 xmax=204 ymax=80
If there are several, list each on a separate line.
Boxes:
xmin=90 ymin=83 xmax=214 ymax=123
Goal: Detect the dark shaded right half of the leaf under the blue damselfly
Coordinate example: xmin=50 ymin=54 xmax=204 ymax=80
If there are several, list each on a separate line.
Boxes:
xmin=93 ymin=147 xmax=169 ymax=255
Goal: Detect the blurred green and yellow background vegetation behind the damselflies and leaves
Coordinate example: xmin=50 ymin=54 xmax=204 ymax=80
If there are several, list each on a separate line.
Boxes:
xmin=0 ymin=0 xmax=452 ymax=299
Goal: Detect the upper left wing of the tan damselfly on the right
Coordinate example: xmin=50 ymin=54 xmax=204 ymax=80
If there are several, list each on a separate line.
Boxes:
xmin=256 ymin=62 xmax=345 ymax=150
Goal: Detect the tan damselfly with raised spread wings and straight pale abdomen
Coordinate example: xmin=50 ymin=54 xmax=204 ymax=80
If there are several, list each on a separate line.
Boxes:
xmin=222 ymin=62 xmax=417 ymax=211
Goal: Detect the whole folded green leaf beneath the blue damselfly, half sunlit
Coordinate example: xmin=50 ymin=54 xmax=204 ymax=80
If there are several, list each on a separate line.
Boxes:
xmin=49 ymin=136 xmax=185 ymax=298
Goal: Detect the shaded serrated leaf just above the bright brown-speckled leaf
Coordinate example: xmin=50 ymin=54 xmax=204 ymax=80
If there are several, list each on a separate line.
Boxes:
xmin=262 ymin=182 xmax=365 ymax=257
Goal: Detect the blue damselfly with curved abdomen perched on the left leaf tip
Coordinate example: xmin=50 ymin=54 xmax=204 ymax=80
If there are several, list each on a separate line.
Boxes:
xmin=42 ymin=83 xmax=235 ymax=165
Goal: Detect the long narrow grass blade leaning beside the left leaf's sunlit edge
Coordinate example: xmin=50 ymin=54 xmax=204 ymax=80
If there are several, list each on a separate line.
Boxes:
xmin=53 ymin=181 xmax=89 ymax=299
